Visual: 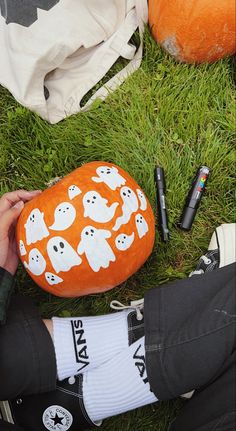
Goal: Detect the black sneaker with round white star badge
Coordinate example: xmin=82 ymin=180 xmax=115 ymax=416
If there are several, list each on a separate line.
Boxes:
xmin=8 ymin=374 xmax=99 ymax=431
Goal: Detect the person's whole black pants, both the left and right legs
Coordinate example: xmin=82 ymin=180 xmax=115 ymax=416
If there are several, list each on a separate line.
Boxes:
xmin=0 ymin=264 xmax=236 ymax=431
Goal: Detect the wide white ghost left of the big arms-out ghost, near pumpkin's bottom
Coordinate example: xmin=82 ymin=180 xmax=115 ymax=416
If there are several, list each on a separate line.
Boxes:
xmin=47 ymin=236 xmax=82 ymax=273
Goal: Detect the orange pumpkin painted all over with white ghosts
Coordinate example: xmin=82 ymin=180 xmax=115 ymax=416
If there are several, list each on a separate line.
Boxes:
xmin=16 ymin=161 xmax=155 ymax=297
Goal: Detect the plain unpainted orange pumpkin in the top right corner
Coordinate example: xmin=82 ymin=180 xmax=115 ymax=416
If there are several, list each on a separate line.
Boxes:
xmin=149 ymin=0 xmax=236 ymax=63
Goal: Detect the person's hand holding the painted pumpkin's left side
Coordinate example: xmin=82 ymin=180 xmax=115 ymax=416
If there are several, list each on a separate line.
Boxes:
xmin=0 ymin=190 xmax=41 ymax=275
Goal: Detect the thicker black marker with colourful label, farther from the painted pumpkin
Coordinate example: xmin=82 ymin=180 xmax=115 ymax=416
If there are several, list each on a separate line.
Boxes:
xmin=179 ymin=166 xmax=210 ymax=230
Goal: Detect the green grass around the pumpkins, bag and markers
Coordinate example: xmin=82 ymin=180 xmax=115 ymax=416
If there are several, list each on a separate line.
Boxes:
xmin=0 ymin=28 xmax=235 ymax=431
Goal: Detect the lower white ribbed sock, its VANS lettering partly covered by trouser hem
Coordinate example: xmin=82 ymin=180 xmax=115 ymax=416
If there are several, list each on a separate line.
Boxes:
xmin=83 ymin=337 xmax=157 ymax=421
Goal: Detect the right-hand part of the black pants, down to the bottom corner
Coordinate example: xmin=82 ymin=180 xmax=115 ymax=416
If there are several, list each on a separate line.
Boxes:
xmin=144 ymin=264 xmax=236 ymax=431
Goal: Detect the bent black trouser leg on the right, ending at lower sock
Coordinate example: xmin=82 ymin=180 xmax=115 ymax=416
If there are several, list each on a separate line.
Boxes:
xmin=144 ymin=264 xmax=236 ymax=400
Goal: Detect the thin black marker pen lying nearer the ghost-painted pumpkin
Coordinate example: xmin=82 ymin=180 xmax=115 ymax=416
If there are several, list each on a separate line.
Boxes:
xmin=155 ymin=166 xmax=170 ymax=242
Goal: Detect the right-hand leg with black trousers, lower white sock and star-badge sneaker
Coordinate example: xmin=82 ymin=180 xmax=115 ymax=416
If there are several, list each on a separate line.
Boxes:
xmin=6 ymin=265 xmax=235 ymax=429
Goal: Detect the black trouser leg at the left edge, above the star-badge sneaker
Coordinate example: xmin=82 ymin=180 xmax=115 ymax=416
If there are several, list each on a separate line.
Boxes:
xmin=0 ymin=295 xmax=56 ymax=400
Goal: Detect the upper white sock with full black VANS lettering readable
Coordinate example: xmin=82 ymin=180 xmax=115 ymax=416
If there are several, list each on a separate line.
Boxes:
xmin=52 ymin=310 xmax=138 ymax=380
